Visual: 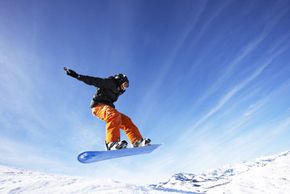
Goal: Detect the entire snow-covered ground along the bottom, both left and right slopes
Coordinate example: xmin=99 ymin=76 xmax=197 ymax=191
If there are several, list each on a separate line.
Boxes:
xmin=0 ymin=151 xmax=290 ymax=194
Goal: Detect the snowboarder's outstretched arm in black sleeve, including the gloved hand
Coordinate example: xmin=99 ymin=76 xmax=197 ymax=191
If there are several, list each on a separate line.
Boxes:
xmin=64 ymin=67 xmax=114 ymax=88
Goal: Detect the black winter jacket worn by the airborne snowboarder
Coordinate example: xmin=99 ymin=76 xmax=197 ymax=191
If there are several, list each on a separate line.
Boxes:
xmin=77 ymin=75 xmax=125 ymax=108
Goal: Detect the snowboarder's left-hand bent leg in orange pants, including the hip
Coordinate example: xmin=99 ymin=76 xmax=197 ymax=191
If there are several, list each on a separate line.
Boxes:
xmin=92 ymin=104 xmax=122 ymax=143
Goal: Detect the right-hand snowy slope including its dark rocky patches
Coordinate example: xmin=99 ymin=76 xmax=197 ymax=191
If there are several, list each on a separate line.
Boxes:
xmin=153 ymin=152 xmax=290 ymax=194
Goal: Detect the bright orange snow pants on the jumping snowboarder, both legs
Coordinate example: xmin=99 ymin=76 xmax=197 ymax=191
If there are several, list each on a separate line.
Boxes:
xmin=92 ymin=104 xmax=142 ymax=144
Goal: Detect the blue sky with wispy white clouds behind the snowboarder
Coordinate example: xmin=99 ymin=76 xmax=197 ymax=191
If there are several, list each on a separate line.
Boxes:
xmin=0 ymin=0 xmax=290 ymax=183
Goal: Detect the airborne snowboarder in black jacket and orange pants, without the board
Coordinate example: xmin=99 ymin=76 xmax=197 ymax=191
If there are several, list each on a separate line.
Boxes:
xmin=64 ymin=67 xmax=151 ymax=150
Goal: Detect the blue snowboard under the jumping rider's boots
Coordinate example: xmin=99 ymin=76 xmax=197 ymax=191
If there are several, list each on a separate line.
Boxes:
xmin=78 ymin=144 xmax=161 ymax=163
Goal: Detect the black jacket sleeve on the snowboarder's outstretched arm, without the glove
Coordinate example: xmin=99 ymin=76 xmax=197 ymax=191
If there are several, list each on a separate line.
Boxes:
xmin=77 ymin=75 xmax=114 ymax=89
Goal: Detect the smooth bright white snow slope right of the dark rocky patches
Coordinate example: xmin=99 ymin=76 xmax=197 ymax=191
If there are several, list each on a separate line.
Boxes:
xmin=208 ymin=152 xmax=290 ymax=194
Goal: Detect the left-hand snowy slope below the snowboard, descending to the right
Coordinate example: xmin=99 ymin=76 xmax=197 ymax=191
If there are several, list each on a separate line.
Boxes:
xmin=0 ymin=166 xmax=172 ymax=194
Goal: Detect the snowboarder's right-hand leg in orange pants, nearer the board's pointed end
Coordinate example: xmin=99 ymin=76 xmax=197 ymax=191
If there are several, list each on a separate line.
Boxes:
xmin=120 ymin=113 xmax=142 ymax=144
